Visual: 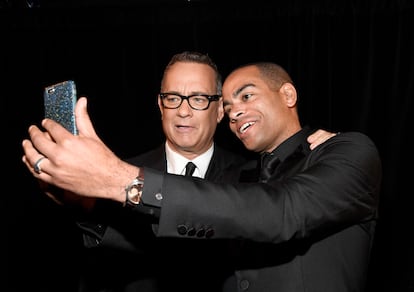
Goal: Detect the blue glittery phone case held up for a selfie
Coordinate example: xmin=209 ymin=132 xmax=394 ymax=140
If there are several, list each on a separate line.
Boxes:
xmin=44 ymin=80 xmax=78 ymax=135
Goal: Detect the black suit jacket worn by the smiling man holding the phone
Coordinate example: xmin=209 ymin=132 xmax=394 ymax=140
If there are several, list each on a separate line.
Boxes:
xmin=142 ymin=128 xmax=381 ymax=292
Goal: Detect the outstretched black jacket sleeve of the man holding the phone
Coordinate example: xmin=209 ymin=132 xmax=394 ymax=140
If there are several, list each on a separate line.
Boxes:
xmin=143 ymin=133 xmax=381 ymax=243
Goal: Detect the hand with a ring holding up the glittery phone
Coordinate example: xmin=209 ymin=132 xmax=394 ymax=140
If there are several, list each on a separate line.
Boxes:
xmin=22 ymin=97 xmax=139 ymax=202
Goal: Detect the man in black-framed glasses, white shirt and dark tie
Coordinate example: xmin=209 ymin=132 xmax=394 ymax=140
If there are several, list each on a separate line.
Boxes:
xmin=22 ymin=52 xmax=332 ymax=292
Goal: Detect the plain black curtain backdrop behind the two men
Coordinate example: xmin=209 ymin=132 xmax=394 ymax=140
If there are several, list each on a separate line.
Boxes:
xmin=4 ymin=0 xmax=414 ymax=292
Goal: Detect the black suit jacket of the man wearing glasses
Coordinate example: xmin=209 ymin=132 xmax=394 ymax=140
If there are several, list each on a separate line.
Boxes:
xmin=79 ymin=145 xmax=245 ymax=292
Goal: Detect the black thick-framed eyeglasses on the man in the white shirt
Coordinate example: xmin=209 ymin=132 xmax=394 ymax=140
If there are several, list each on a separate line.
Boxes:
xmin=160 ymin=92 xmax=221 ymax=111
